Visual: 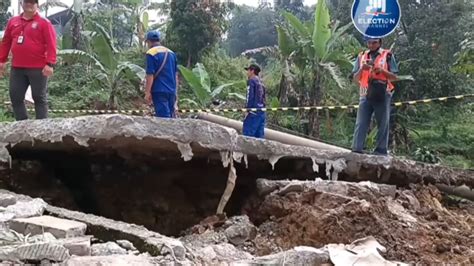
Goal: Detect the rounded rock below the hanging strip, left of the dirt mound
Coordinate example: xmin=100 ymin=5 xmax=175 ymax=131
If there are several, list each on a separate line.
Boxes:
xmin=224 ymin=216 xmax=257 ymax=245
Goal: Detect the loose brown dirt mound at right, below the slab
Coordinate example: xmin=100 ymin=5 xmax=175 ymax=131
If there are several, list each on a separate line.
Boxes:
xmin=245 ymin=183 xmax=474 ymax=264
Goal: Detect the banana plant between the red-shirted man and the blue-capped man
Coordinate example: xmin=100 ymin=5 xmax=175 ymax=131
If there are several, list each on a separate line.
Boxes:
xmin=58 ymin=21 xmax=145 ymax=108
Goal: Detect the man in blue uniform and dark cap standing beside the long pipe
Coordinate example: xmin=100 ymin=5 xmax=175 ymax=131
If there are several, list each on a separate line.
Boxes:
xmin=243 ymin=64 xmax=265 ymax=138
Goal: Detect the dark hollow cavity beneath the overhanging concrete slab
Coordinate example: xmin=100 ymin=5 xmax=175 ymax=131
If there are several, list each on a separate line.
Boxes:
xmin=0 ymin=137 xmax=326 ymax=236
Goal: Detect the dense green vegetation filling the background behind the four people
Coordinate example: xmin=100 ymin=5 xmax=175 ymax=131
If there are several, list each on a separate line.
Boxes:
xmin=0 ymin=0 xmax=474 ymax=168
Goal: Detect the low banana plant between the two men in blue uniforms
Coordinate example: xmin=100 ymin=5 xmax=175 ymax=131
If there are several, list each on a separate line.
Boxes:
xmin=178 ymin=63 xmax=245 ymax=108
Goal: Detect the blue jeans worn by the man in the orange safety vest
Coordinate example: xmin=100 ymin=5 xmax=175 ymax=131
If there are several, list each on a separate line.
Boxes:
xmin=352 ymin=92 xmax=392 ymax=155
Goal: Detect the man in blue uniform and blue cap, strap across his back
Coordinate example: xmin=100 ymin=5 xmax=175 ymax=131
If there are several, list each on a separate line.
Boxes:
xmin=145 ymin=31 xmax=178 ymax=118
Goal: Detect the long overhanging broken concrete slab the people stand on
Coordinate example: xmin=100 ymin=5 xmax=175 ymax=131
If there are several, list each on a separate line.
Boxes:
xmin=0 ymin=115 xmax=468 ymax=188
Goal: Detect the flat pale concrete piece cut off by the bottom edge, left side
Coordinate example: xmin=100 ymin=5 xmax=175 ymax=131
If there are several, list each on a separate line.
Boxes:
xmin=61 ymin=255 xmax=158 ymax=266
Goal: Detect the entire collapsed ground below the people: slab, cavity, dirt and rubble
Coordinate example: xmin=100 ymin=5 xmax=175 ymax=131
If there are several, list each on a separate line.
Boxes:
xmin=0 ymin=115 xmax=474 ymax=265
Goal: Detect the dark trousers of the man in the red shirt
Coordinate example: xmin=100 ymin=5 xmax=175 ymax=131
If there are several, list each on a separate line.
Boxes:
xmin=10 ymin=67 xmax=48 ymax=120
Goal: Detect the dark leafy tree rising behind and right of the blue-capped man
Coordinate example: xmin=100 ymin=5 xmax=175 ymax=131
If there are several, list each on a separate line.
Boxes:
xmin=166 ymin=0 xmax=227 ymax=67
